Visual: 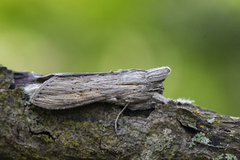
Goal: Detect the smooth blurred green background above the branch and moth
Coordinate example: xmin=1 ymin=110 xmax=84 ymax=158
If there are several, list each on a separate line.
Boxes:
xmin=0 ymin=0 xmax=240 ymax=116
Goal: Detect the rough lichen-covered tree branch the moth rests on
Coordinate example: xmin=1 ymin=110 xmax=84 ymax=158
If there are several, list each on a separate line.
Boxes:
xmin=0 ymin=66 xmax=240 ymax=160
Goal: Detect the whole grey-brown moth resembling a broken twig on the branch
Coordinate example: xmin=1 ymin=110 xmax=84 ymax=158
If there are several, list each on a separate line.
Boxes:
xmin=24 ymin=67 xmax=171 ymax=110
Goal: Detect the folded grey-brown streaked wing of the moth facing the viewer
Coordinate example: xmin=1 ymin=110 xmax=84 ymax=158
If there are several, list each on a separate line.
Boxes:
xmin=30 ymin=76 xmax=110 ymax=109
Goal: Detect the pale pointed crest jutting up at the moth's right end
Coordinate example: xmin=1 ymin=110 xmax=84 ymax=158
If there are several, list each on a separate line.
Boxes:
xmin=146 ymin=67 xmax=171 ymax=82
